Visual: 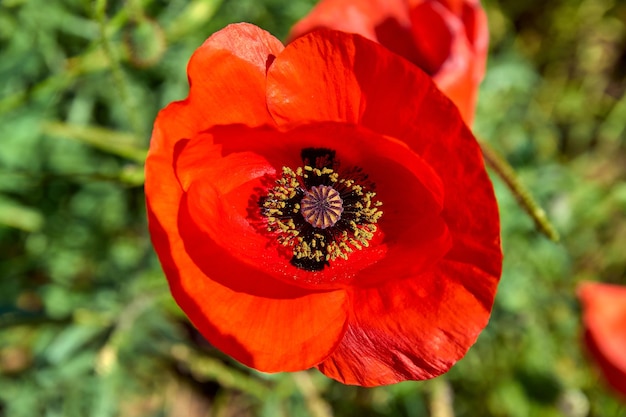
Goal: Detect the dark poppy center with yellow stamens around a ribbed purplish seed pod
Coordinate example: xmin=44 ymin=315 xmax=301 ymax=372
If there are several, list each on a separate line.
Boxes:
xmin=259 ymin=148 xmax=383 ymax=271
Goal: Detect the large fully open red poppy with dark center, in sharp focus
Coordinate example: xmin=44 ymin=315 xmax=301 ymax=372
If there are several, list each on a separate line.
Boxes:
xmin=145 ymin=24 xmax=501 ymax=386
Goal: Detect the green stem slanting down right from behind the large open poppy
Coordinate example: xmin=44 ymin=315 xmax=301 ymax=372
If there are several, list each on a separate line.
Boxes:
xmin=480 ymin=141 xmax=559 ymax=242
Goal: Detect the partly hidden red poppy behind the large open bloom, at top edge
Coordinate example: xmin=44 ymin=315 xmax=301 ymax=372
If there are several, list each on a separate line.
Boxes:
xmin=290 ymin=0 xmax=489 ymax=125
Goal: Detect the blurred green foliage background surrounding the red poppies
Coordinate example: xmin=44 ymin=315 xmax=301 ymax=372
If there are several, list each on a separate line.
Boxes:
xmin=0 ymin=0 xmax=626 ymax=417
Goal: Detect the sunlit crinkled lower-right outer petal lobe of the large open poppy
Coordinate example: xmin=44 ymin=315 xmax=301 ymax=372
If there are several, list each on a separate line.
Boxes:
xmin=318 ymin=261 xmax=495 ymax=386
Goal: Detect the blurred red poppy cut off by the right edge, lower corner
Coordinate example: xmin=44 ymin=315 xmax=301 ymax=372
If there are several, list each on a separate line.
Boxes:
xmin=578 ymin=282 xmax=626 ymax=395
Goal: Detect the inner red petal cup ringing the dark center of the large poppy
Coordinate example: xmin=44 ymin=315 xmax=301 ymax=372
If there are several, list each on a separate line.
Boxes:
xmin=177 ymin=123 xmax=450 ymax=289
